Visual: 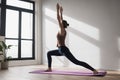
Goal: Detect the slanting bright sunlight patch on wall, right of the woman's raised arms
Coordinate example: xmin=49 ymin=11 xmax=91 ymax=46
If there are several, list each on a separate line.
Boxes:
xmin=64 ymin=16 xmax=100 ymax=40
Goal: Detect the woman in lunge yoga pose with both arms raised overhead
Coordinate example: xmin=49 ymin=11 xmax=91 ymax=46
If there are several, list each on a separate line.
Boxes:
xmin=46 ymin=3 xmax=98 ymax=74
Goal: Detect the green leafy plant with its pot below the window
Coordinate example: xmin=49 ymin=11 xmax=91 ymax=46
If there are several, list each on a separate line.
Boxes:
xmin=0 ymin=41 xmax=12 ymax=69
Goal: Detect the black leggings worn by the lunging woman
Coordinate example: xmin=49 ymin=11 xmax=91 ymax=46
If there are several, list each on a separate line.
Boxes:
xmin=47 ymin=46 xmax=95 ymax=71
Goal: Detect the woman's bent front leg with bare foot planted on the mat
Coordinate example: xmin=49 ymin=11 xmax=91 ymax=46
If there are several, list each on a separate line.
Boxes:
xmin=46 ymin=50 xmax=62 ymax=71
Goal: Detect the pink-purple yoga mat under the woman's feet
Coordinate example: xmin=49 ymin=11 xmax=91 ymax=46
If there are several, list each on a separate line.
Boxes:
xmin=30 ymin=70 xmax=106 ymax=76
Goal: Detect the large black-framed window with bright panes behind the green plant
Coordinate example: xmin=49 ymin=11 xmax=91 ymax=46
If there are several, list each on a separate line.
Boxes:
xmin=5 ymin=0 xmax=35 ymax=60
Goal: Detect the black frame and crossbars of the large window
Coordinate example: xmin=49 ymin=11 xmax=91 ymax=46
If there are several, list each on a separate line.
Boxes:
xmin=0 ymin=0 xmax=35 ymax=60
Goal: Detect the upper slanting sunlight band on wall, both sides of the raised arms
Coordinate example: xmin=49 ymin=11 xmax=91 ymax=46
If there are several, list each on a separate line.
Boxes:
xmin=45 ymin=8 xmax=100 ymax=40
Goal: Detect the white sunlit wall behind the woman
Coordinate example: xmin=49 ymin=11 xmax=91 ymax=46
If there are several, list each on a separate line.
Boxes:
xmin=42 ymin=0 xmax=120 ymax=70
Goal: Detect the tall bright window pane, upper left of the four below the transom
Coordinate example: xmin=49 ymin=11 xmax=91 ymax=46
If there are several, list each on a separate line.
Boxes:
xmin=6 ymin=9 xmax=19 ymax=38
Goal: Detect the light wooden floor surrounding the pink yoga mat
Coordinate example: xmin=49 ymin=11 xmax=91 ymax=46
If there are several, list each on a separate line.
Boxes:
xmin=0 ymin=65 xmax=120 ymax=80
